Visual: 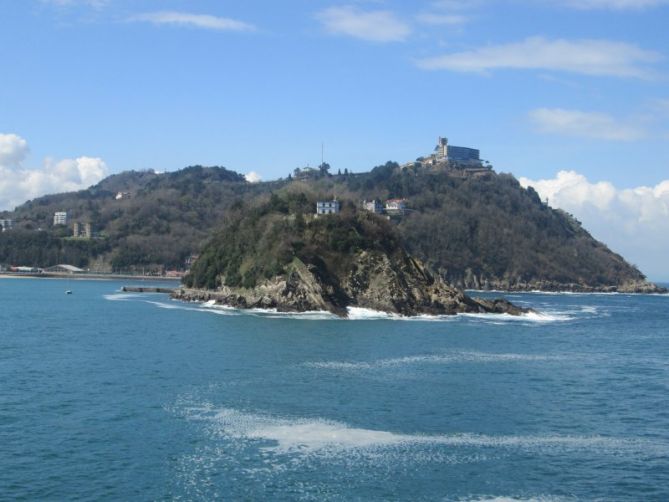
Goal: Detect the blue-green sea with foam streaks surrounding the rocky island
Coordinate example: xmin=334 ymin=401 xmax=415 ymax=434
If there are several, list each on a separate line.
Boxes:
xmin=0 ymin=279 xmax=669 ymax=501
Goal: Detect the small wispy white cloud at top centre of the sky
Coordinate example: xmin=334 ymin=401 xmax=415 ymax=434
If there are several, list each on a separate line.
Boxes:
xmin=316 ymin=6 xmax=411 ymax=42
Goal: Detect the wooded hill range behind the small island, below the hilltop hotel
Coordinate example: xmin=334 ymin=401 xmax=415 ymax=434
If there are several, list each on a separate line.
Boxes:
xmin=0 ymin=162 xmax=657 ymax=292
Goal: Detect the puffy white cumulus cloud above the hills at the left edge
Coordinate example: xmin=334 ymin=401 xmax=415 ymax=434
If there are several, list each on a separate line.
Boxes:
xmin=0 ymin=134 xmax=107 ymax=210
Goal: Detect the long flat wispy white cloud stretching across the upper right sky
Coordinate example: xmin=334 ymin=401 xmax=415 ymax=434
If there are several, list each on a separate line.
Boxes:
xmin=417 ymin=37 xmax=661 ymax=78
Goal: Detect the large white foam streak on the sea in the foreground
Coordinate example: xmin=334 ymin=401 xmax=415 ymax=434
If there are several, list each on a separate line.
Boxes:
xmin=179 ymin=405 xmax=656 ymax=455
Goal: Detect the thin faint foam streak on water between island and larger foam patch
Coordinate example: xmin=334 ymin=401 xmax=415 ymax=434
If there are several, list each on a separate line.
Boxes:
xmin=303 ymin=352 xmax=566 ymax=371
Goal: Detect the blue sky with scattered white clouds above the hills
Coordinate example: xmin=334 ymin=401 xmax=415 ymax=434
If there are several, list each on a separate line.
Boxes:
xmin=0 ymin=0 xmax=669 ymax=281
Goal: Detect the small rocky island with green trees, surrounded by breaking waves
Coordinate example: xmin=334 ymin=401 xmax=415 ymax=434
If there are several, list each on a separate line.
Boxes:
xmin=173 ymin=193 xmax=527 ymax=317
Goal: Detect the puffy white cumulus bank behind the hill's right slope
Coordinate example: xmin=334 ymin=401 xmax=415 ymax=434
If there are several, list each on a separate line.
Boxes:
xmin=519 ymin=171 xmax=669 ymax=280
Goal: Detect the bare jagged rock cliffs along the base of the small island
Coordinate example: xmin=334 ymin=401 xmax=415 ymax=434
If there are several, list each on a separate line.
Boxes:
xmin=172 ymin=252 xmax=530 ymax=317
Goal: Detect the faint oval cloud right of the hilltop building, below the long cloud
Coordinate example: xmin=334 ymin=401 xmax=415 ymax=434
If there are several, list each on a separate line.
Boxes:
xmin=529 ymin=108 xmax=646 ymax=141
